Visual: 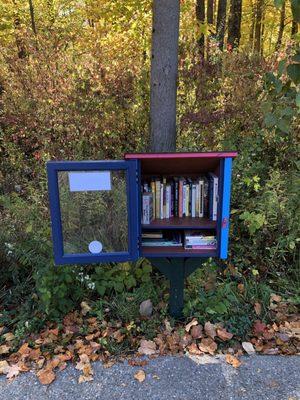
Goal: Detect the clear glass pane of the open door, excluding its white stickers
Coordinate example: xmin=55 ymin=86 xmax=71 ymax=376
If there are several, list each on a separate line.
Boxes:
xmin=58 ymin=170 xmax=128 ymax=254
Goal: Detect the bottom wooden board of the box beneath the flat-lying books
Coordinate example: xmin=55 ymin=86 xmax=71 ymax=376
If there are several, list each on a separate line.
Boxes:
xmin=142 ymin=246 xmax=217 ymax=258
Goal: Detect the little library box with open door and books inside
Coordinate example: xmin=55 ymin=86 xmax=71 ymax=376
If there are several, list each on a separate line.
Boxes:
xmin=47 ymin=152 xmax=237 ymax=265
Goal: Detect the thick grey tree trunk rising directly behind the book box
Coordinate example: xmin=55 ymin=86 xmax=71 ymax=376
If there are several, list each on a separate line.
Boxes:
xmin=150 ymin=0 xmax=180 ymax=152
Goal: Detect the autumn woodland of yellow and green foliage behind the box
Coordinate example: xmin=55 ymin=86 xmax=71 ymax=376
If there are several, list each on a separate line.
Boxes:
xmin=0 ymin=0 xmax=300 ymax=352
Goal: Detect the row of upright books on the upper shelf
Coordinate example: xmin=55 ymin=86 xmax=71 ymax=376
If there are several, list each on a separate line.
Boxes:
xmin=142 ymin=173 xmax=219 ymax=224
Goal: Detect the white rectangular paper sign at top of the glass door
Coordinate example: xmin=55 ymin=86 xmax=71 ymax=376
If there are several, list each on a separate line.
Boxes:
xmin=69 ymin=171 xmax=111 ymax=192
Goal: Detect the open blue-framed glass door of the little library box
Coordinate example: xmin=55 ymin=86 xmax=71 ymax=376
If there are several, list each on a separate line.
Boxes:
xmin=47 ymin=160 xmax=140 ymax=265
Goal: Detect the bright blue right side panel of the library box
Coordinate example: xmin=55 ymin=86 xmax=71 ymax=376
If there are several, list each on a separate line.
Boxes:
xmin=219 ymin=158 xmax=232 ymax=259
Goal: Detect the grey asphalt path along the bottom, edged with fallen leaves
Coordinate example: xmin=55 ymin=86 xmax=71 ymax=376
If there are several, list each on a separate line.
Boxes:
xmin=0 ymin=356 xmax=300 ymax=400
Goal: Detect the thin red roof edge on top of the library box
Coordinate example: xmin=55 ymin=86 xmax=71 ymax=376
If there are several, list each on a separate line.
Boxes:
xmin=124 ymin=151 xmax=238 ymax=160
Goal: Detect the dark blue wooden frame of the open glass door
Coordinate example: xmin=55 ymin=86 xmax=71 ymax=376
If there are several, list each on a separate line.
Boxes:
xmin=47 ymin=160 xmax=141 ymax=265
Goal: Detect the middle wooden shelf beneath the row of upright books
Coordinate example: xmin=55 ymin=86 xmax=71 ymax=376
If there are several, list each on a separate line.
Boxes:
xmin=142 ymin=217 xmax=217 ymax=229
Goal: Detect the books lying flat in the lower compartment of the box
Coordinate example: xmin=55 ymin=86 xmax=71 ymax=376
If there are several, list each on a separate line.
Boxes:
xmin=142 ymin=231 xmax=217 ymax=250
